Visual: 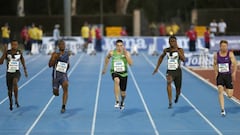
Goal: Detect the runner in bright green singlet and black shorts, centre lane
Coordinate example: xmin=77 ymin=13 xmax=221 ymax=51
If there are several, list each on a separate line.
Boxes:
xmin=102 ymin=40 xmax=133 ymax=109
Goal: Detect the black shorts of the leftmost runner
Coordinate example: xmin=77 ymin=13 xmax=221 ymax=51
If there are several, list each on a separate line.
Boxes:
xmin=6 ymin=70 xmax=21 ymax=90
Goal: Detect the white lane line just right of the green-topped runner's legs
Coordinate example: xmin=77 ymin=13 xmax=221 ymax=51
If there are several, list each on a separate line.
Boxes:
xmin=128 ymin=67 xmax=159 ymax=135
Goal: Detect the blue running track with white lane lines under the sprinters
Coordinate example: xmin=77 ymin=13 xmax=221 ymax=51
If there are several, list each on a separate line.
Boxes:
xmin=0 ymin=52 xmax=240 ymax=135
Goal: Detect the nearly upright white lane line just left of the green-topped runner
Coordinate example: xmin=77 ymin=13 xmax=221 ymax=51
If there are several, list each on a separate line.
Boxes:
xmin=91 ymin=54 xmax=104 ymax=135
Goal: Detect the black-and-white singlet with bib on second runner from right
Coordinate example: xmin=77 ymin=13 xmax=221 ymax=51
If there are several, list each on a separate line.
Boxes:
xmin=166 ymin=48 xmax=180 ymax=70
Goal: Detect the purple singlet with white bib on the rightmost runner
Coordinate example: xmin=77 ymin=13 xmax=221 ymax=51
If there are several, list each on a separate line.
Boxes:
xmin=217 ymin=51 xmax=232 ymax=74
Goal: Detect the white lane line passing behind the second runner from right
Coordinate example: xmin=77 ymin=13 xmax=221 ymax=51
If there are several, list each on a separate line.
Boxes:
xmin=143 ymin=54 xmax=223 ymax=135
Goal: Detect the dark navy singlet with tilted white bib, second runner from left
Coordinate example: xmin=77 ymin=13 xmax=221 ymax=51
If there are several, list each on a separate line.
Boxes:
xmin=53 ymin=51 xmax=69 ymax=73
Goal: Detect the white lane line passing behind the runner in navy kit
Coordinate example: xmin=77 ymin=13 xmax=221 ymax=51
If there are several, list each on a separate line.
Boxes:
xmin=25 ymin=54 xmax=83 ymax=135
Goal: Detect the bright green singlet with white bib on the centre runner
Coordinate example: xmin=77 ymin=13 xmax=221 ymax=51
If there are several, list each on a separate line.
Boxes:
xmin=111 ymin=50 xmax=127 ymax=77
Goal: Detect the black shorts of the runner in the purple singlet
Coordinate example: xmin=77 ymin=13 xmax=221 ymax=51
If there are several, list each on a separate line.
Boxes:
xmin=216 ymin=73 xmax=233 ymax=89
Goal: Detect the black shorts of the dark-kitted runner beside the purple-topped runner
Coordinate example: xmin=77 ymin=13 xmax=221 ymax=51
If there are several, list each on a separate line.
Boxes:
xmin=166 ymin=68 xmax=182 ymax=89
